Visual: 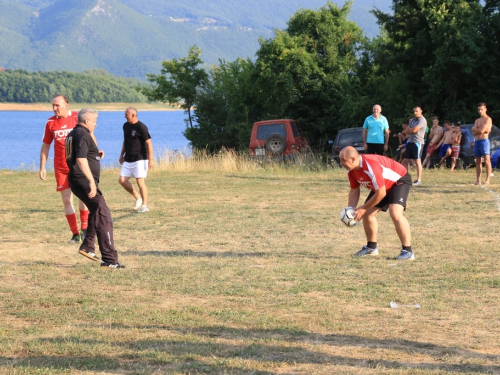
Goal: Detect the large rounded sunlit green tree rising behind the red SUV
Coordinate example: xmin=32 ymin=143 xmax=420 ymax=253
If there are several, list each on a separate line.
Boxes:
xmin=256 ymin=1 xmax=364 ymax=146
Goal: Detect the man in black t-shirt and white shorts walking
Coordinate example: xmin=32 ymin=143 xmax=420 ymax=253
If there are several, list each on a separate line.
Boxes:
xmin=118 ymin=107 xmax=154 ymax=212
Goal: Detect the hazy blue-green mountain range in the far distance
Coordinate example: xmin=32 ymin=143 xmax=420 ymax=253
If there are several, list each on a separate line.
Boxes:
xmin=0 ymin=0 xmax=392 ymax=79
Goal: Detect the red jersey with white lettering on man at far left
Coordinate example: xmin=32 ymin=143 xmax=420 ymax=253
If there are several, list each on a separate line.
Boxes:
xmin=43 ymin=111 xmax=78 ymax=173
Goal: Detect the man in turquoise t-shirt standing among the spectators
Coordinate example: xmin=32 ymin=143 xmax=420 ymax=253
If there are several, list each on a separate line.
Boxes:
xmin=363 ymin=104 xmax=389 ymax=155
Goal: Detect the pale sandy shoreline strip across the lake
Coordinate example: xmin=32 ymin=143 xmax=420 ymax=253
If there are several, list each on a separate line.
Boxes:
xmin=0 ymin=103 xmax=181 ymax=112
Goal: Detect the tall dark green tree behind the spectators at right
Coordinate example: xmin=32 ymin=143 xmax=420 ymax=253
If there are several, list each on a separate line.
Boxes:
xmin=372 ymin=0 xmax=485 ymax=120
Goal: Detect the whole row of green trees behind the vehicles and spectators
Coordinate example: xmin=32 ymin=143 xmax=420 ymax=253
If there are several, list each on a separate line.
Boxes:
xmin=141 ymin=0 xmax=500 ymax=151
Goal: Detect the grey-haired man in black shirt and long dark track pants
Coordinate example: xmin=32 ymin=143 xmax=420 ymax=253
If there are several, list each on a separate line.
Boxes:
xmin=66 ymin=109 xmax=125 ymax=268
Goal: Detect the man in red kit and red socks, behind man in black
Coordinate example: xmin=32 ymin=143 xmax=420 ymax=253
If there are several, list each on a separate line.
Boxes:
xmin=39 ymin=95 xmax=89 ymax=243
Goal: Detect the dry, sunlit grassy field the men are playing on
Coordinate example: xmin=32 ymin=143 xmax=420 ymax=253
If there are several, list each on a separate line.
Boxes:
xmin=0 ymin=157 xmax=500 ymax=374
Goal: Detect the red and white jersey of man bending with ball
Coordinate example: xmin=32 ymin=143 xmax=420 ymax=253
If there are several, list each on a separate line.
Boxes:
xmin=348 ymin=154 xmax=408 ymax=192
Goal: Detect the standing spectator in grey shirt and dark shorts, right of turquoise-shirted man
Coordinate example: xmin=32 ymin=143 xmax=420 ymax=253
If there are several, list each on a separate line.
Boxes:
xmin=403 ymin=106 xmax=427 ymax=185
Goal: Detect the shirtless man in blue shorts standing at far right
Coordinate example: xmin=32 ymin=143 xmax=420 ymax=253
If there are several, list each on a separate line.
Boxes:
xmin=472 ymin=102 xmax=493 ymax=185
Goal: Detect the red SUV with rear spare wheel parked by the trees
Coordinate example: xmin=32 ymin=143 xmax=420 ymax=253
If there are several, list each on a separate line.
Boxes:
xmin=249 ymin=119 xmax=307 ymax=157
